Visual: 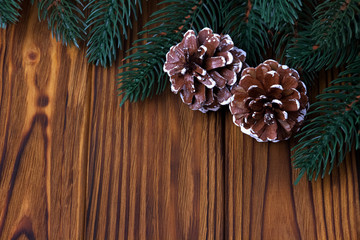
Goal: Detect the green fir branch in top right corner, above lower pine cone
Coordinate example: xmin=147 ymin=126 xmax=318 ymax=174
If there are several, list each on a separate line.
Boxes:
xmin=286 ymin=0 xmax=360 ymax=71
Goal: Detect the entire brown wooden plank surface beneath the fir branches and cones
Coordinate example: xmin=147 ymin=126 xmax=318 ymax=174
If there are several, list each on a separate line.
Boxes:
xmin=0 ymin=1 xmax=360 ymax=240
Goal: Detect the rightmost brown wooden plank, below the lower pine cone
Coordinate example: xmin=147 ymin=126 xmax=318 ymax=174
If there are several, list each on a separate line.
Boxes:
xmin=225 ymin=68 xmax=360 ymax=239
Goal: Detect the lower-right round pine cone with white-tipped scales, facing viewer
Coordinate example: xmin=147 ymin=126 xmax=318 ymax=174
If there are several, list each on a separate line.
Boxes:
xmin=229 ymin=60 xmax=309 ymax=142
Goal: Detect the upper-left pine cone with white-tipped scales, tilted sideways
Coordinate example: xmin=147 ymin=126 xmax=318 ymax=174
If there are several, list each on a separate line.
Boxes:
xmin=164 ymin=28 xmax=246 ymax=113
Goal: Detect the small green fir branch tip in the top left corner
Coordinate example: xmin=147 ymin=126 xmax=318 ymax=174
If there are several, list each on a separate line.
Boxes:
xmin=0 ymin=0 xmax=21 ymax=28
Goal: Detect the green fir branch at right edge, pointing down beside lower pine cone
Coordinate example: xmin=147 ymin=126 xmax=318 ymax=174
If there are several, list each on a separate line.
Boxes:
xmin=292 ymin=56 xmax=360 ymax=184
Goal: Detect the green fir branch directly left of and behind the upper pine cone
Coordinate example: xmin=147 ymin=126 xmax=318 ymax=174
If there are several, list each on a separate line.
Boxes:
xmin=118 ymin=0 xmax=225 ymax=105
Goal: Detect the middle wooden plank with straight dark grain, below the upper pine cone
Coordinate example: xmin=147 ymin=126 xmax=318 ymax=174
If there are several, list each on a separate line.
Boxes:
xmin=85 ymin=1 xmax=224 ymax=239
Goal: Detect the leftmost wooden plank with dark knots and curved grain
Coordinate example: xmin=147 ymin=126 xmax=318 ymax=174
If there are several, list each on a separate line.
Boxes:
xmin=0 ymin=1 xmax=90 ymax=239
